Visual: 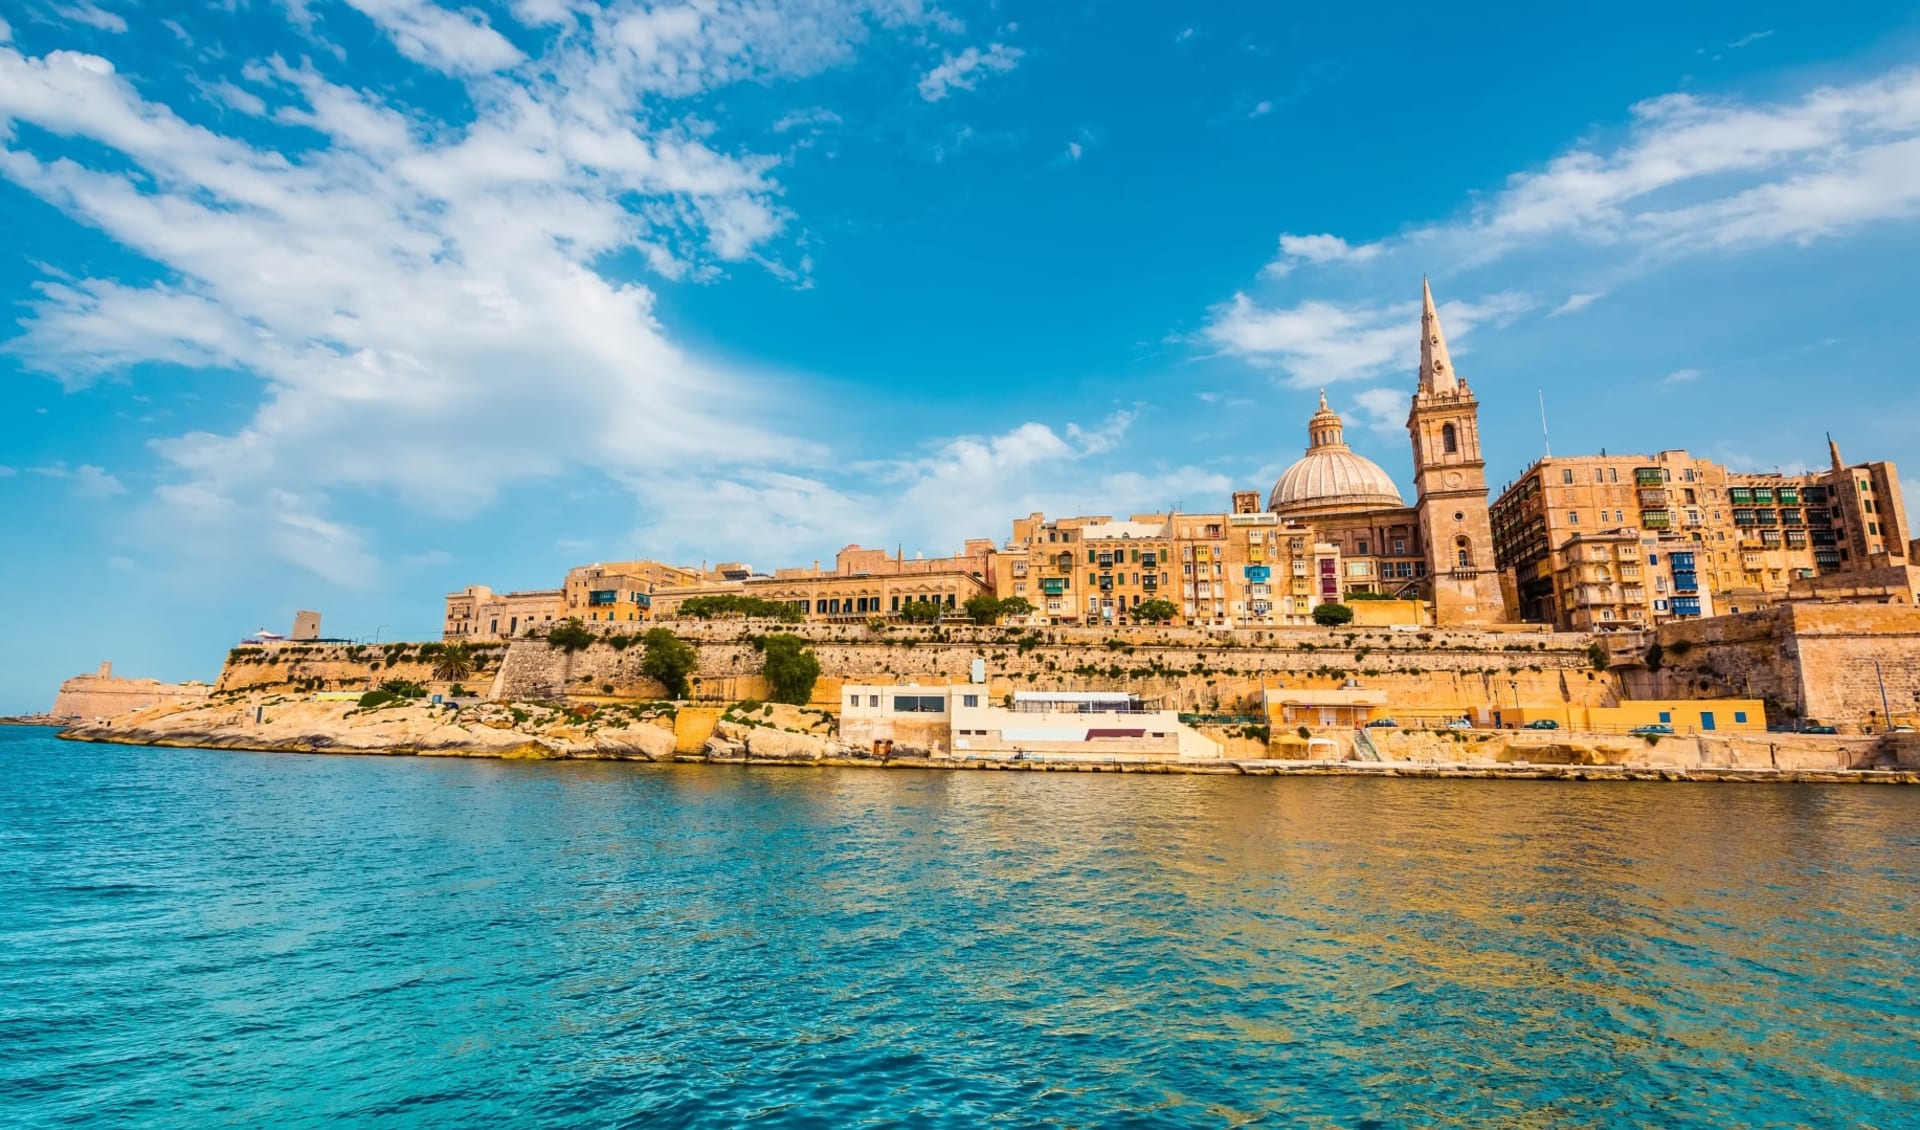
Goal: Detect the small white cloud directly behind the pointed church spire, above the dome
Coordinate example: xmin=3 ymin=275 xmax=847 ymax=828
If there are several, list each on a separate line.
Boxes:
xmin=1202 ymin=292 xmax=1534 ymax=388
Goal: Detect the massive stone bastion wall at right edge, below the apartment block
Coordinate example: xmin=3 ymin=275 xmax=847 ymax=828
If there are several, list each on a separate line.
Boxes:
xmin=1620 ymin=604 xmax=1920 ymax=729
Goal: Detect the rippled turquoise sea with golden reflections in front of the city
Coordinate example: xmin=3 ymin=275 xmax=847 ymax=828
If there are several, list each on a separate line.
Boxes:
xmin=0 ymin=729 xmax=1920 ymax=1128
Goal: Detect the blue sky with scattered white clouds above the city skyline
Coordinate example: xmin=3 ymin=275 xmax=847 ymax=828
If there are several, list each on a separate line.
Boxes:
xmin=0 ymin=0 xmax=1920 ymax=712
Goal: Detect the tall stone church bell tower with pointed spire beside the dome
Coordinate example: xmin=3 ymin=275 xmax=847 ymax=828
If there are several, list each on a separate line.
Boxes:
xmin=1407 ymin=278 xmax=1511 ymax=627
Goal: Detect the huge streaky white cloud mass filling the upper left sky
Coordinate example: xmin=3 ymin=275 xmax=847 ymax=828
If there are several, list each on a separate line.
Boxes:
xmin=0 ymin=8 xmax=956 ymax=583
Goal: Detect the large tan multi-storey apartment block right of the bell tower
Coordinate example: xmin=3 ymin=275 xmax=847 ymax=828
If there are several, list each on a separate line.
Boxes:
xmin=1492 ymin=443 xmax=1907 ymax=627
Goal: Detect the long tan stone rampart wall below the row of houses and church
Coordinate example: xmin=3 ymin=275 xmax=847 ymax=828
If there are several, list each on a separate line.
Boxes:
xmin=492 ymin=622 xmax=1619 ymax=710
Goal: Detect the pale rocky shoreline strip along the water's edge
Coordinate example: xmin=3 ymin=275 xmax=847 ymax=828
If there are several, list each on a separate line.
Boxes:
xmin=60 ymin=696 xmax=1920 ymax=785
